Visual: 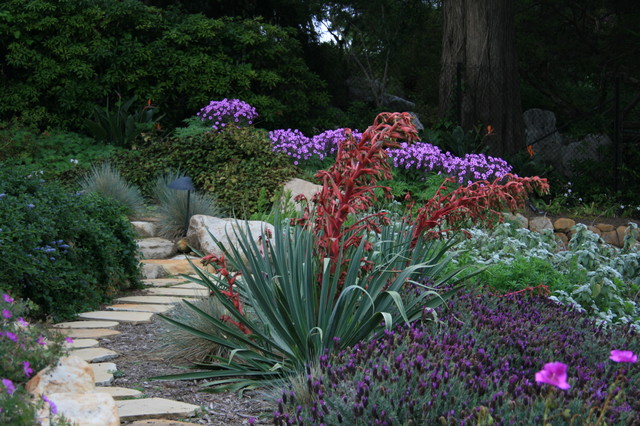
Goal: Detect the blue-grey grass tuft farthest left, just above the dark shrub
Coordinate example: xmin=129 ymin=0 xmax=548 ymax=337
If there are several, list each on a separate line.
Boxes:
xmin=80 ymin=162 xmax=144 ymax=216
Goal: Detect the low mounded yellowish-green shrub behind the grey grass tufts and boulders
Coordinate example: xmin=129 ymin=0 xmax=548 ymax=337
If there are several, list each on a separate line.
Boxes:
xmin=116 ymin=126 xmax=294 ymax=217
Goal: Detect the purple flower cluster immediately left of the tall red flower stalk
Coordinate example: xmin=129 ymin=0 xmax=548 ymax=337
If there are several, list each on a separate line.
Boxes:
xmin=269 ymin=129 xmax=362 ymax=165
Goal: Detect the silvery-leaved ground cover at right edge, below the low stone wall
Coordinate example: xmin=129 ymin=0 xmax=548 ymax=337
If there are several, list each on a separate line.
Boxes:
xmin=454 ymin=223 xmax=640 ymax=327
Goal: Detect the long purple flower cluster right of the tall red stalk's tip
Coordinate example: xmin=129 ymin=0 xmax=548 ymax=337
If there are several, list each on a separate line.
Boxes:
xmin=388 ymin=142 xmax=512 ymax=184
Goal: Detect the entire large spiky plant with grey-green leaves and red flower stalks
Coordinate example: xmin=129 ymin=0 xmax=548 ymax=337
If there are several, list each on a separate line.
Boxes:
xmin=155 ymin=113 xmax=546 ymax=390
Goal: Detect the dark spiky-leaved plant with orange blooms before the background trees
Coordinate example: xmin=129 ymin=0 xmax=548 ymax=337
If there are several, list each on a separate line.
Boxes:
xmin=85 ymin=96 xmax=163 ymax=148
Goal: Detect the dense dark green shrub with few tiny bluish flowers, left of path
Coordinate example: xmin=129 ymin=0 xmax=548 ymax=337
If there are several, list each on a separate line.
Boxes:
xmin=0 ymin=164 xmax=140 ymax=320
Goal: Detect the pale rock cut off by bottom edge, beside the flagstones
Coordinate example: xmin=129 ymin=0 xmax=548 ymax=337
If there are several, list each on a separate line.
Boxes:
xmin=38 ymin=392 xmax=120 ymax=426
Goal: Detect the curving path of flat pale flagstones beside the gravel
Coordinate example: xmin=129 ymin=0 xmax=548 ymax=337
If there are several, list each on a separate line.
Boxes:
xmin=53 ymin=278 xmax=208 ymax=426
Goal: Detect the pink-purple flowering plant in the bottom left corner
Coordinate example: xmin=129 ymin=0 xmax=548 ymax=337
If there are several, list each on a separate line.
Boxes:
xmin=0 ymin=288 xmax=70 ymax=426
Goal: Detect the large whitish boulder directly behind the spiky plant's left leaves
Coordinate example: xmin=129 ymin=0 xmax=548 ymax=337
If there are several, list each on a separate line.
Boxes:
xmin=187 ymin=215 xmax=274 ymax=260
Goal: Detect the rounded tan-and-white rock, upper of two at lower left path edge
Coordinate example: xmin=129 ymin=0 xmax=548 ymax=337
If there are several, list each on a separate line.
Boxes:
xmin=25 ymin=356 xmax=95 ymax=397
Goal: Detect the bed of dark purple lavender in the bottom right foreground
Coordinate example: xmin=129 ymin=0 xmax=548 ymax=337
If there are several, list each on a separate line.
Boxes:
xmin=273 ymin=292 xmax=640 ymax=425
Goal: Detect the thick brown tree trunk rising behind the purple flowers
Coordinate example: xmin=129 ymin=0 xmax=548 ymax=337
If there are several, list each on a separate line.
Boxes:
xmin=440 ymin=0 xmax=525 ymax=156
